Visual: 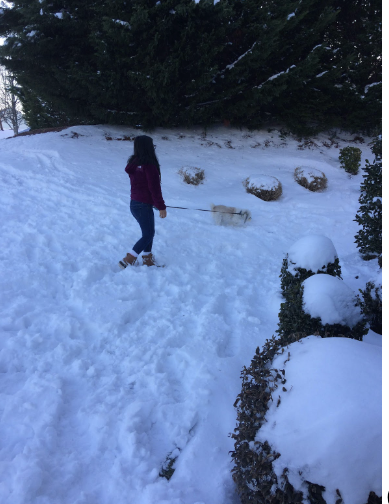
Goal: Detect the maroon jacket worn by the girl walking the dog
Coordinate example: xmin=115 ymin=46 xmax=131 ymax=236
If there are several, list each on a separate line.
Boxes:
xmin=125 ymin=160 xmax=166 ymax=210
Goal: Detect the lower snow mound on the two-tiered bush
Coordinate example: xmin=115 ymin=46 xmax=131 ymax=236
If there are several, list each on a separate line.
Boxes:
xmin=302 ymin=274 xmax=362 ymax=327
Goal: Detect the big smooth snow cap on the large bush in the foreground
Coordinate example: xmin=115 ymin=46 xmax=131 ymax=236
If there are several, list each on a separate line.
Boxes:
xmin=256 ymin=334 xmax=382 ymax=504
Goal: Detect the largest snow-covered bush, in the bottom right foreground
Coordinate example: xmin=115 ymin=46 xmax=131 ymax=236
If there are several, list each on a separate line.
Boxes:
xmin=232 ymin=334 xmax=381 ymax=504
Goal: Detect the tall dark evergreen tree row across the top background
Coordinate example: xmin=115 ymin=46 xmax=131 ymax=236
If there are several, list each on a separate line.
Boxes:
xmin=0 ymin=0 xmax=381 ymax=132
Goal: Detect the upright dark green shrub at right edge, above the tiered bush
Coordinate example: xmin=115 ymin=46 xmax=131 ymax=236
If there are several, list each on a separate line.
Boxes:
xmin=355 ymin=138 xmax=382 ymax=267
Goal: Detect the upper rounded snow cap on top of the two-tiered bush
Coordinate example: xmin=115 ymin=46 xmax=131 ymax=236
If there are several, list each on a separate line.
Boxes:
xmin=288 ymin=234 xmax=338 ymax=273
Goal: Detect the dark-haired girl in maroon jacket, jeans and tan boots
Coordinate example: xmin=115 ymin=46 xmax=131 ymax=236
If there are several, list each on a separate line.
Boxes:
xmin=119 ymin=135 xmax=166 ymax=269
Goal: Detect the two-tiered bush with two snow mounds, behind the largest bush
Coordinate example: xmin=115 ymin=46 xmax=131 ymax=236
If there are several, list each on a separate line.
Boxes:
xmin=276 ymin=235 xmax=367 ymax=340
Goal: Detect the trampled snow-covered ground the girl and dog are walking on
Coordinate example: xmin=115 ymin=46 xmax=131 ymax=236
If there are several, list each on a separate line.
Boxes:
xmin=0 ymin=126 xmax=381 ymax=504
